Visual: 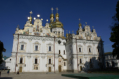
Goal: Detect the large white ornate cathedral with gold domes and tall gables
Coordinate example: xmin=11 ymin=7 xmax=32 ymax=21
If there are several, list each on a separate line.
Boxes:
xmin=6 ymin=8 xmax=104 ymax=73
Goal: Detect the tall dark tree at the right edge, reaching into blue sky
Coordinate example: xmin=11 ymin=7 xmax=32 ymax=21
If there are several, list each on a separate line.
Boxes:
xmin=110 ymin=1 xmax=119 ymax=59
